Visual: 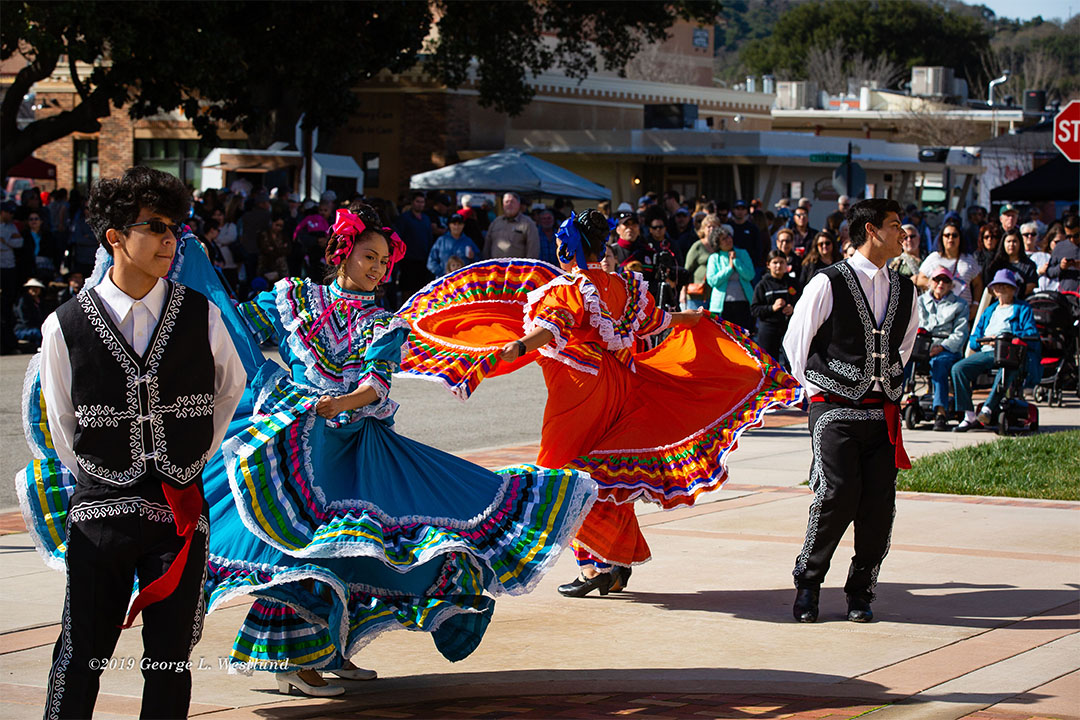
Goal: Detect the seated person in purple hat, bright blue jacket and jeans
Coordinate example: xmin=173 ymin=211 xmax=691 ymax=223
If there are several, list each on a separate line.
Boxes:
xmin=953 ymin=270 xmax=1040 ymax=433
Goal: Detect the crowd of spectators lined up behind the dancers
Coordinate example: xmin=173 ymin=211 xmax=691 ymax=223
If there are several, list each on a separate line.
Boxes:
xmin=0 ymin=174 xmax=1080 ymax=382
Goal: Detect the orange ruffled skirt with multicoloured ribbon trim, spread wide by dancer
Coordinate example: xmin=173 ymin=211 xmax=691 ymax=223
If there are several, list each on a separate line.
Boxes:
xmin=400 ymin=260 xmax=801 ymax=566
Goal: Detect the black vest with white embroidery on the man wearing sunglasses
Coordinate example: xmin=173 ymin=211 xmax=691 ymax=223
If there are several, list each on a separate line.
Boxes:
xmin=56 ymin=281 xmax=214 ymax=487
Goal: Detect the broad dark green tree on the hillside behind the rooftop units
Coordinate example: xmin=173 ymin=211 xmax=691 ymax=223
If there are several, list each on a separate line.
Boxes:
xmin=742 ymin=0 xmax=991 ymax=81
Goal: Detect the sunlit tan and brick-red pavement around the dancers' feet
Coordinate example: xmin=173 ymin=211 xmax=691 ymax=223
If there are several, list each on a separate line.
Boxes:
xmin=0 ymin=358 xmax=1080 ymax=720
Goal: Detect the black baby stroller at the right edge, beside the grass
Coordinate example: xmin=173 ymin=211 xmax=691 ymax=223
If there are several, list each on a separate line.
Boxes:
xmin=1027 ymin=290 xmax=1080 ymax=407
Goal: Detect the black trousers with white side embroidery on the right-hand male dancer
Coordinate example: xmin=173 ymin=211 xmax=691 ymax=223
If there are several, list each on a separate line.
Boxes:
xmin=792 ymin=403 xmax=896 ymax=600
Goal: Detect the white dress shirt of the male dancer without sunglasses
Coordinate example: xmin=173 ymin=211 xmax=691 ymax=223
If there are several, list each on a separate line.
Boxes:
xmin=784 ymin=253 xmax=919 ymax=395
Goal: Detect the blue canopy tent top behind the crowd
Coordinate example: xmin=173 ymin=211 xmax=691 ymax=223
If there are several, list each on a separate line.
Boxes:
xmin=409 ymin=149 xmax=611 ymax=200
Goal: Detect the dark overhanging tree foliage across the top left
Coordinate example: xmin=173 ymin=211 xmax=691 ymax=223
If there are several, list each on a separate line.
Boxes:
xmin=0 ymin=0 xmax=720 ymax=173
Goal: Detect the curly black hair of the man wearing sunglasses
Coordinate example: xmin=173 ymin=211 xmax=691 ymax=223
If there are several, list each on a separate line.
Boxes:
xmin=86 ymin=165 xmax=191 ymax=255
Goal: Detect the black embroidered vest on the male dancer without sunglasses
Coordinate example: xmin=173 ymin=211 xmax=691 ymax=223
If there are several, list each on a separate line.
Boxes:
xmin=806 ymin=261 xmax=915 ymax=400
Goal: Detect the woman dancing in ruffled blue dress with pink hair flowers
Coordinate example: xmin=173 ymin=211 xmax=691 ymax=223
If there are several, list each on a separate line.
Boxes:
xmin=22 ymin=206 xmax=596 ymax=695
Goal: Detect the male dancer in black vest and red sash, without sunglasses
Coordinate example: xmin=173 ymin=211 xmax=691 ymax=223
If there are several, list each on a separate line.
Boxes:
xmin=784 ymin=199 xmax=919 ymax=623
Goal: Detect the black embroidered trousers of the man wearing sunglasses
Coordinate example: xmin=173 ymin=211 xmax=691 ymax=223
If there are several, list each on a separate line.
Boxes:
xmin=44 ymin=487 xmax=208 ymax=720
